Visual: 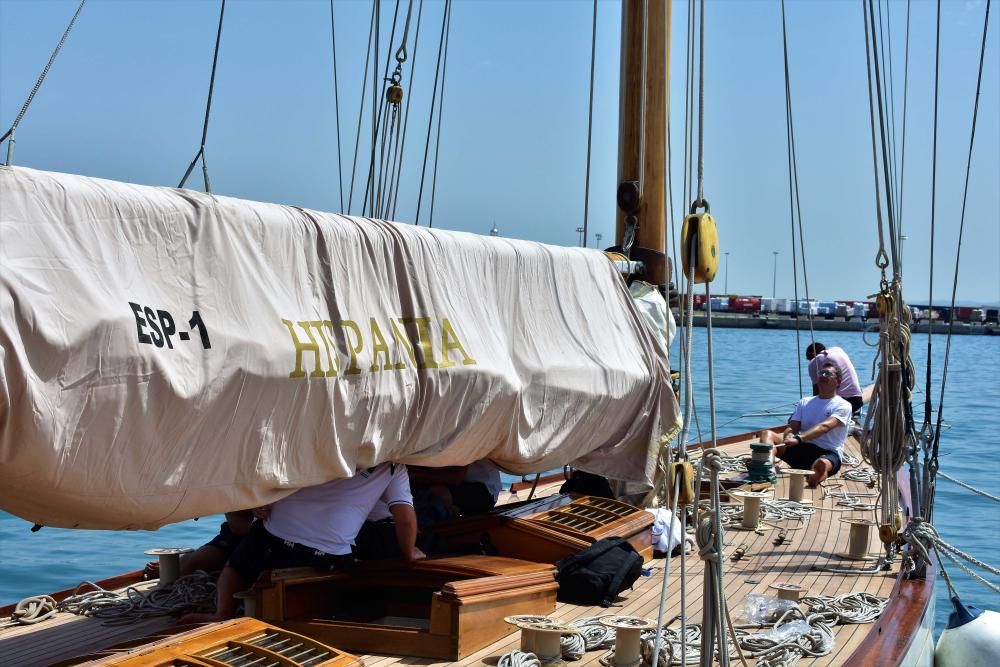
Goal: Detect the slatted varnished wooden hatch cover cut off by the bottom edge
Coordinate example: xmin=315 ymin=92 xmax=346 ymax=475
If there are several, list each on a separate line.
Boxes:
xmin=54 ymin=618 xmax=364 ymax=667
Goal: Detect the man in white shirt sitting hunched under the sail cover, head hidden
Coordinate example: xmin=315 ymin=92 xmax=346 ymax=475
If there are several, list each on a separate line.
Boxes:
xmin=178 ymin=463 xmax=425 ymax=623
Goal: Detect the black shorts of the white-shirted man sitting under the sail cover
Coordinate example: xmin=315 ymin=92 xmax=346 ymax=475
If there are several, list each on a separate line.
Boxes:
xmin=229 ymin=521 xmax=354 ymax=585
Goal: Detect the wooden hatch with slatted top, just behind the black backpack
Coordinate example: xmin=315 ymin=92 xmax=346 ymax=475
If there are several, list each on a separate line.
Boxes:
xmin=435 ymin=494 xmax=654 ymax=563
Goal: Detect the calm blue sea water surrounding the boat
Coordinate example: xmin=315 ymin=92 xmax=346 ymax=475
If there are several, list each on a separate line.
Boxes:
xmin=0 ymin=329 xmax=1000 ymax=627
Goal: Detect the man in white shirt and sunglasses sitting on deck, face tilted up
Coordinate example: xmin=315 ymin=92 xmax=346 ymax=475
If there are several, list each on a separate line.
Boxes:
xmin=760 ymin=361 xmax=851 ymax=488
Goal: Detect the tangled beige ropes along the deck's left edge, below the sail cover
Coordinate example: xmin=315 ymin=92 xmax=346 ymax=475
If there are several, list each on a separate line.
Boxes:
xmin=8 ymin=572 xmax=215 ymax=625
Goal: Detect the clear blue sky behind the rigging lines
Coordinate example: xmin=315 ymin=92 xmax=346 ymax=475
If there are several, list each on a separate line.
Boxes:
xmin=0 ymin=0 xmax=1000 ymax=303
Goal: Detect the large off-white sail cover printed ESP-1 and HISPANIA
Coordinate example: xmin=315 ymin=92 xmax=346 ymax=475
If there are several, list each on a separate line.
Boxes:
xmin=0 ymin=168 xmax=678 ymax=529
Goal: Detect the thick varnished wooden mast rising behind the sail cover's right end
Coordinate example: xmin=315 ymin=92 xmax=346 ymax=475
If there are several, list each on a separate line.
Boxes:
xmin=615 ymin=0 xmax=670 ymax=285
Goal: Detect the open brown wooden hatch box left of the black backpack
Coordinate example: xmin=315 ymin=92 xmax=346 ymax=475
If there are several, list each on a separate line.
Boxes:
xmin=254 ymin=555 xmax=559 ymax=660
